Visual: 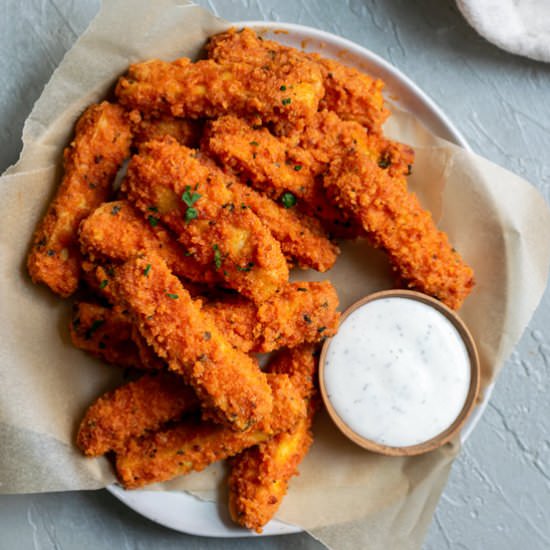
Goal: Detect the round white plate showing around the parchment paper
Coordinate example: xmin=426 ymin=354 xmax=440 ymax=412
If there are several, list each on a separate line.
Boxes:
xmin=107 ymin=21 xmax=493 ymax=537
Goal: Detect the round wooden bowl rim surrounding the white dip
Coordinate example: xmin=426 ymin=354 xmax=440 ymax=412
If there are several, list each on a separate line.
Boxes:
xmin=319 ymin=290 xmax=481 ymax=456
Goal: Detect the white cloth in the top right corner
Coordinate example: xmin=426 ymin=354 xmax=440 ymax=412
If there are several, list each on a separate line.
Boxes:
xmin=457 ymin=0 xmax=550 ymax=62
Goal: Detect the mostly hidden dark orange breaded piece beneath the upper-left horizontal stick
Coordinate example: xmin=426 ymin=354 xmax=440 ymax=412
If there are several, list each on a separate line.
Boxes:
xmin=129 ymin=110 xmax=203 ymax=147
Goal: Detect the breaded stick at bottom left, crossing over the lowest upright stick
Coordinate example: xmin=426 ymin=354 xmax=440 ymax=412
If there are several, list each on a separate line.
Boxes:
xmin=116 ymin=375 xmax=307 ymax=489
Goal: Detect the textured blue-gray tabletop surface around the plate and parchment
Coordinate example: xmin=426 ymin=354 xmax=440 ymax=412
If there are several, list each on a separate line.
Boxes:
xmin=0 ymin=0 xmax=550 ymax=550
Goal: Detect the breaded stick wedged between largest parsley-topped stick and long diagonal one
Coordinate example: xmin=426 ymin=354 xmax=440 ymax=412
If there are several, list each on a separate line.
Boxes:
xmin=79 ymin=200 xmax=219 ymax=284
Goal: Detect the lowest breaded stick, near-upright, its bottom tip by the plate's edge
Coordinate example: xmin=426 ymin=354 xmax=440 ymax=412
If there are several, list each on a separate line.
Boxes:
xmin=229 ymin=345 xmax=317 ymax=533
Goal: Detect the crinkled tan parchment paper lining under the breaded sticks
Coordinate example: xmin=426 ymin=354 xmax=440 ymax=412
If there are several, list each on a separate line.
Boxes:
xmin=0 ymin=0 xmax=550 ymax=549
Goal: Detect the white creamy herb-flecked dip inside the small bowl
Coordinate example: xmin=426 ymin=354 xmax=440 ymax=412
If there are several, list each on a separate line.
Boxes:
xmin=324 ymin=297 xmax=471 ymax=447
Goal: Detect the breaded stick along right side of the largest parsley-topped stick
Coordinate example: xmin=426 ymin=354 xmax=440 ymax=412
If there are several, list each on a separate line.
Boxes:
xmin=231 ymin=182 xmax=340 ymax=272
